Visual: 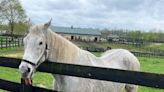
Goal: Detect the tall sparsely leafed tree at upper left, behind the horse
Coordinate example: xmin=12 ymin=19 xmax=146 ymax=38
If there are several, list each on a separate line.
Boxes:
xmin=0 ymin=0 xmax=26 ymax=35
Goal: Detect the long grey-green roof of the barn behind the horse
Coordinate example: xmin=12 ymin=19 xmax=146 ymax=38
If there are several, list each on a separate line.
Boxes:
xmin=51 ymin=26 xmax=101 ymax=36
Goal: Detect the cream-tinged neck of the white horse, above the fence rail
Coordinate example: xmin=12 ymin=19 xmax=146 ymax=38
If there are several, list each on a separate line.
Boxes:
xmin=48 ymin=30 xmax=80 ymax=63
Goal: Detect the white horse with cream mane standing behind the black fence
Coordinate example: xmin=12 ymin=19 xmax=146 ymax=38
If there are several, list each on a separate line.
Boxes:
xmin=19 ymin=20 xmax=140 ymax=92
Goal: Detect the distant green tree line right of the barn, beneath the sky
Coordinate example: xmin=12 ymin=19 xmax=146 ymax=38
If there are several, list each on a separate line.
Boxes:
xmin=101 ymin=29 xmax=164 ymax=43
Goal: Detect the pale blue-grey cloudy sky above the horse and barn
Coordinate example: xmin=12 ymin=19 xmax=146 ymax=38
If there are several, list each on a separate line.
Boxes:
xmin=20 ymin=0 xmax=164 ymax=30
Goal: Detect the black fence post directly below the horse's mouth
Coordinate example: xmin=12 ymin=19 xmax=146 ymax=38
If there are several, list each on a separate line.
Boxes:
xmin=20 ymin=78 xmax=33 ymax=92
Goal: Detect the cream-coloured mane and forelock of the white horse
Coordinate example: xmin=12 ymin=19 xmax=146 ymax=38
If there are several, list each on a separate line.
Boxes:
xmin=30 ymin=24 xmax=80 ymax=63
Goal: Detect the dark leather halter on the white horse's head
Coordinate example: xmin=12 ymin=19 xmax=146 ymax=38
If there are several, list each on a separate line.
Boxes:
xmin=22 ymin=43 xmax=48 ymax=67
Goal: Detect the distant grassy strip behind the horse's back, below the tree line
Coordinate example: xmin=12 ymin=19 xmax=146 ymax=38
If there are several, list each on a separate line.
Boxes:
xmin=73 ymin=42 xmax=164 ymax=52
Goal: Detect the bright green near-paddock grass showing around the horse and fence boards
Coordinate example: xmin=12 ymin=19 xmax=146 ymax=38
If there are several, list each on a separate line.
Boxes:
xmin=0 ymin=48 xmax=164 ymax=92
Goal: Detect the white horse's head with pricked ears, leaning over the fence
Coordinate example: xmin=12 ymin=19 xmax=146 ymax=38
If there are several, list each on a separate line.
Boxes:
xmin=19 ymin=20 xmax=51 ymax=83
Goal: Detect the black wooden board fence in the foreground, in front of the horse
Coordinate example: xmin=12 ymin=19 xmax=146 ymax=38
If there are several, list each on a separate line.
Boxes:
xmin=0 ymin=57 xmax=164 ymax=92
